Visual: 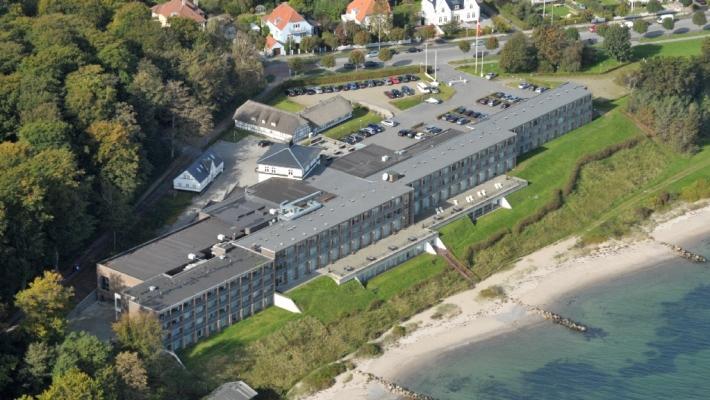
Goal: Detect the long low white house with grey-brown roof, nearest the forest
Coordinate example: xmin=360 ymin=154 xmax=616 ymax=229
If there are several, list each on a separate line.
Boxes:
xmin=234 ymin=100 xmax=311 ymax=143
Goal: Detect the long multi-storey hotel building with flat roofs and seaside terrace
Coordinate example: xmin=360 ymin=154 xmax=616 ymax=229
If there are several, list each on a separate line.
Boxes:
xmin=97 ymin=83 xmax=592 ymax=350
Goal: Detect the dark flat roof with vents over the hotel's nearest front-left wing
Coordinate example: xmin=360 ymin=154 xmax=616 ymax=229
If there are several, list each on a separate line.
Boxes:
xmin=123 ymin=246 xmax=271 ymax=311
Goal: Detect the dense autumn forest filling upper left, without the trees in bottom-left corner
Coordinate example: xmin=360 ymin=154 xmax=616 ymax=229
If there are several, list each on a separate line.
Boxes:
xmin=0 ymin=0 xmax=263 ymax=302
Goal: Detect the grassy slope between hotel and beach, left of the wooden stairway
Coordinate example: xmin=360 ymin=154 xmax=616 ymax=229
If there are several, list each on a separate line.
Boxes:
xmin=181 ymin=255 xmax=466 ymax=395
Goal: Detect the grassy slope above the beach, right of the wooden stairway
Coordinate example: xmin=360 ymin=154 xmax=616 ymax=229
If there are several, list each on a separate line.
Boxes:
xmin=441 ymin=98 xmax=710 ymax=277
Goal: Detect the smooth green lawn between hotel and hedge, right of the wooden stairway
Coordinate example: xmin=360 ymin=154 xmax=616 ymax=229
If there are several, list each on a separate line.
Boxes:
xmin=440 ymin=102 xmax=640 ymax=258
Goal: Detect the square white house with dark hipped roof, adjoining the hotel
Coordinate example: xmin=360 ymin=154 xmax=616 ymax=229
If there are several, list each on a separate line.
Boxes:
xmin=256 ymin=143 xmax=320 ymax=182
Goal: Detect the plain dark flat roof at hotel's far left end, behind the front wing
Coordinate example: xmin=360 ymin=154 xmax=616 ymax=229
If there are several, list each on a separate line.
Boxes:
xmin=102 ymin=218 xmax=235 ymax=281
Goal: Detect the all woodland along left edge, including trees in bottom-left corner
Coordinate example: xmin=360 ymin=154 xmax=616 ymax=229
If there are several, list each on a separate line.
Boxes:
xmin=0 ymin=0 xmax=264 ymax=399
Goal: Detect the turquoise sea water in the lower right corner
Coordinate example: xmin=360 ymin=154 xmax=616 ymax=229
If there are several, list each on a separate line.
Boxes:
xmin=398 ymin=238 xmax=710 ymax=400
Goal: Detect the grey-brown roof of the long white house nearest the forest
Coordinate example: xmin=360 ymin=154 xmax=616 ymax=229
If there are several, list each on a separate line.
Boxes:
xmin=234 ymin=100 xmax=308 ymax=135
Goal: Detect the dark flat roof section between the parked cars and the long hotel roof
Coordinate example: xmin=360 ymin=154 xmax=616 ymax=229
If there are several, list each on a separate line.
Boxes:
xmin=330 ymin=144 xmax=409 ymax=178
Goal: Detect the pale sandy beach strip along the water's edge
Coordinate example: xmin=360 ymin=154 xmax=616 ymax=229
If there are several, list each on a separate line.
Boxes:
xmin=309 ymin=203 xmax=710 ymax=400
